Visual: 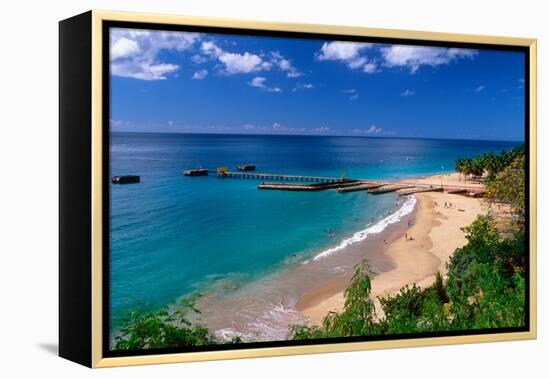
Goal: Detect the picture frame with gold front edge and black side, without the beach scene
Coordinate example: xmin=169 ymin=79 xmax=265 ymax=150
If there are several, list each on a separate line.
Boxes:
xmin=59 ymin=10 xmax=537 ymax=368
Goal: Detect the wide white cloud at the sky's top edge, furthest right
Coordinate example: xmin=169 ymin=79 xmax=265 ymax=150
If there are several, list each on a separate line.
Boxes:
xmin=380 ymin=45 xmax=477 ymax=73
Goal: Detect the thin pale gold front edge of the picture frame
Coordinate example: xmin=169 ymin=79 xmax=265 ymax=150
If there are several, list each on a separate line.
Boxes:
xmin=91 ymin=10 xmax=537 ymax=368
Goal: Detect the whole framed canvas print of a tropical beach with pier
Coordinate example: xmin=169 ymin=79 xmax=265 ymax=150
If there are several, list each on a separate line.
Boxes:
xmin=59 ymin=11 xmax=536 ymax=367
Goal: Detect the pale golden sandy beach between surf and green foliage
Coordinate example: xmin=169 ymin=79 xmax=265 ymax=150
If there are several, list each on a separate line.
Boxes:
xmin=297 ymin=173 xmax=487 ymax=324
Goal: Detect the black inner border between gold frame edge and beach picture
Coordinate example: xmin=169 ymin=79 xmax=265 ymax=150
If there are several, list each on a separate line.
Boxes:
xmin=101 ymin=21 xmax=531 ymax=358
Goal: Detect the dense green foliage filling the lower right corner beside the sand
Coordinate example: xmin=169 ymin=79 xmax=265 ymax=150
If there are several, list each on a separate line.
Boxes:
xmin=290 ymin=216 xmax=525 ymax=340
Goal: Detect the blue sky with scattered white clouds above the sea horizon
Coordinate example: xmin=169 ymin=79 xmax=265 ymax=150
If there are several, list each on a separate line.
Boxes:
xmin=110 ymin=29 xmax=524 ymax=141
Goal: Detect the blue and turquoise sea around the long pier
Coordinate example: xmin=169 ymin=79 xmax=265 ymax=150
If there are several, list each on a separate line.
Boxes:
xmin=109 ymin=133 xmax=518 ymax=327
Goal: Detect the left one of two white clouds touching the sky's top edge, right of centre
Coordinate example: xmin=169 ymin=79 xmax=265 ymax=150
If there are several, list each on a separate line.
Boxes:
xmin=317 ymin=41 xmax=377 ymax=73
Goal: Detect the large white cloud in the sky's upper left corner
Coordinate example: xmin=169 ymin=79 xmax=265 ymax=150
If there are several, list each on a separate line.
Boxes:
xmin=110 ymin=28 xmax=200 ymax=80
